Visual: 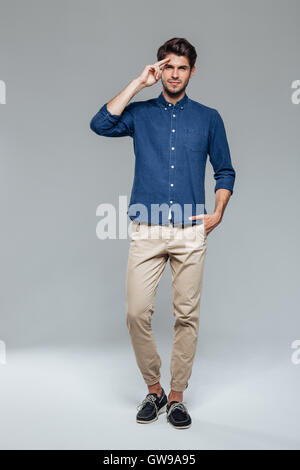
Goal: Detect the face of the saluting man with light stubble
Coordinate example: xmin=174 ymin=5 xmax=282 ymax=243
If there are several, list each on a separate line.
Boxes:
xmin=161 ymin=54 xmax=195 ymax=96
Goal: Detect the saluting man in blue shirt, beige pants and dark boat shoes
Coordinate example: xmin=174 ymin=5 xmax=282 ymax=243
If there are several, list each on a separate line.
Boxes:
xmin=90 ymin=38 xmax=235 ymax=429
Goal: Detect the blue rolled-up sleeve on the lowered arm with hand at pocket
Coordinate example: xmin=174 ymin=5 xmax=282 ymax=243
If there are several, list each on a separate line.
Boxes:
xmin=208 ymin=110 xmax=236 ymax=194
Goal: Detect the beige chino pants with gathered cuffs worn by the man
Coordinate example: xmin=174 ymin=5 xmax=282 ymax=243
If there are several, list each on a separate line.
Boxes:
xmin=126 ymin=221 xmax=207 ymax=392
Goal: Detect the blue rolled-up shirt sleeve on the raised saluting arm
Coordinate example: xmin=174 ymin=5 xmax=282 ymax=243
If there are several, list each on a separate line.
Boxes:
xmin=90 ymin=103 xmax=134 ymax=137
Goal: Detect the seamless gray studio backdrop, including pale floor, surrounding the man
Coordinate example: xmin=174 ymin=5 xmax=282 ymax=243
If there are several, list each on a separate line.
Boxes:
xmin=0 ymin=0 xmax=300 ymax=449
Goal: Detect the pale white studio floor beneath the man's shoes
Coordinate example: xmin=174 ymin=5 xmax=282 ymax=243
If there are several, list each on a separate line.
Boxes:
xmin=0 ymin=344 xmax=300 ymax=450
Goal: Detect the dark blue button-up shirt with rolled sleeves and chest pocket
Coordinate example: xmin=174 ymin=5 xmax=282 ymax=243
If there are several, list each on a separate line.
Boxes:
xmin=90 ymin=92 xmax=235 ymax=225
